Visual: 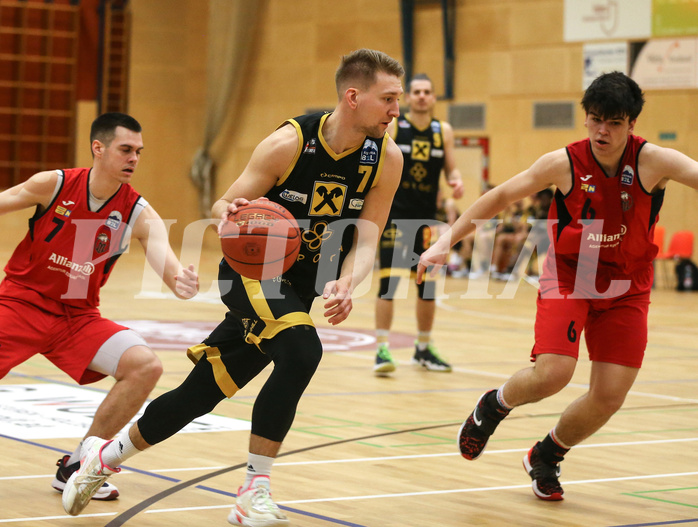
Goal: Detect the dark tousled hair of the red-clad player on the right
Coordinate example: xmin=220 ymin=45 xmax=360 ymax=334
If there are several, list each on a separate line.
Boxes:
xmin=581 ymin=71 xmax=645 ymax=121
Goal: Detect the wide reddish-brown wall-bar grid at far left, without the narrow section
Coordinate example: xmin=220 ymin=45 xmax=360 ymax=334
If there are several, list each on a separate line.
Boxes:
xmin=0 ymin=0 xmax=80 ymax=188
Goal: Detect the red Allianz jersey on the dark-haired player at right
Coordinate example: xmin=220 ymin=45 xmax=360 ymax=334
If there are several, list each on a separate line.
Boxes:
xmin=549 ymin=135 xmax=664 ymax=286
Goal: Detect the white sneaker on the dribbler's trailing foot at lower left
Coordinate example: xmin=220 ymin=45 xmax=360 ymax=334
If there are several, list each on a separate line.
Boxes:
xmin=63 ymin=437 xmax=121 ymax=516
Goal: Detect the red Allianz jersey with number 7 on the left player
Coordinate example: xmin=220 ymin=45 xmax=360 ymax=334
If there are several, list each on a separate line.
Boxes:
xmin=5 ymin=168 xmax=147 ymax=307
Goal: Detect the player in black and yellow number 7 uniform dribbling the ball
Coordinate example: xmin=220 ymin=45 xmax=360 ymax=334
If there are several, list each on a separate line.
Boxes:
xmin=64 ymin=49 xmax=404 ymax=527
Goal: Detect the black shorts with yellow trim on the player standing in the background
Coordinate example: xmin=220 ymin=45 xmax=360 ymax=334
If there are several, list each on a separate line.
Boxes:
xmin=378 ymin=220 xmax=438 ymax=300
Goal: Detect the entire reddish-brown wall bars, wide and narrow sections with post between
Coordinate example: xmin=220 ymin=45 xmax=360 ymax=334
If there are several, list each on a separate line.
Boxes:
xmin=0 ymin=0 xmax=131 ymax=189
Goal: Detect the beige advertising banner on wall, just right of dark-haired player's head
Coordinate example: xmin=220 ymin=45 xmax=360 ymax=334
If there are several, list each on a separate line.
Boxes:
xmin=630 ymin=38 xmax=698 ymax=90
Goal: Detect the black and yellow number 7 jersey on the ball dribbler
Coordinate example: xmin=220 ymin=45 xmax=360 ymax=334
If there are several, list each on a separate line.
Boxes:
xmin=266 ymin=113 xmax=389 ymax=296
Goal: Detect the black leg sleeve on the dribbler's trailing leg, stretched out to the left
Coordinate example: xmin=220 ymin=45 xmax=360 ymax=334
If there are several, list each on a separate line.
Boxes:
xmin=138 ymin=359 xmax=225 ymax=445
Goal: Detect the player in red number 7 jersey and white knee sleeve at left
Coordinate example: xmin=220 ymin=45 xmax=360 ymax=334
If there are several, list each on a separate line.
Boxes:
xmin=0 ymin=113 xmax=198 ymax=500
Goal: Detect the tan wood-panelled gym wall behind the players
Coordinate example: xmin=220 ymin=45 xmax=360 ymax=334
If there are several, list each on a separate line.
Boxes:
xmin=117 ymin=0 xmax=698 ymax=241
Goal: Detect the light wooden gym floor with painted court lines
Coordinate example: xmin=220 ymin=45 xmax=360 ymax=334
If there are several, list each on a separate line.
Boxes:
xmin=0 ymin=232 xmax=698 ymax=527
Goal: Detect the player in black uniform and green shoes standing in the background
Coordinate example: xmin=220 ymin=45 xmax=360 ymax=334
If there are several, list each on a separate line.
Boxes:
xmin=373 ymin=74 xmax=463 ymax=375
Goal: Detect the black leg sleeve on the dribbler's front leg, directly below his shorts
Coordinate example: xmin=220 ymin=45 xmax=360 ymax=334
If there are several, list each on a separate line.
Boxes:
xmin=252 ymin=326 xmax=322 ymax=442
